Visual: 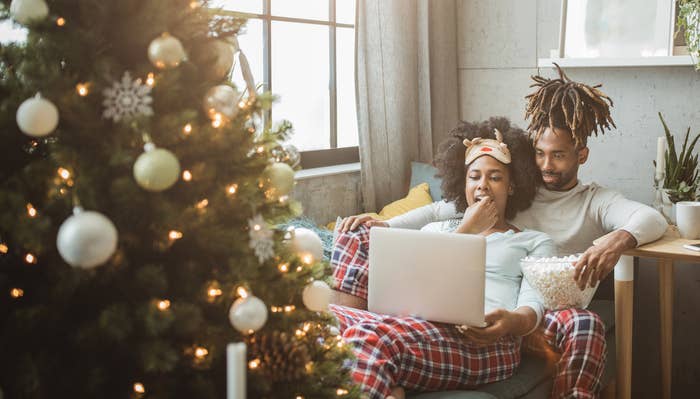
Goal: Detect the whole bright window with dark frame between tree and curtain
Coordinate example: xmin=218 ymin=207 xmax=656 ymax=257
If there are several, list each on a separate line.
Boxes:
xmin=210 ymin=0 xmax=359 ymax=168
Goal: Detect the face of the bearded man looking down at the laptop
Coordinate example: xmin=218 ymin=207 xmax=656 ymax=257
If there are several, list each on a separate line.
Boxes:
xmin=535 ymin=128 xmax=588 ymax=191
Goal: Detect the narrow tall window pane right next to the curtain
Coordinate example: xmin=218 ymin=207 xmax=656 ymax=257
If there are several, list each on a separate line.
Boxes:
xmin=336 ymin=28 xmax=358 ymax=147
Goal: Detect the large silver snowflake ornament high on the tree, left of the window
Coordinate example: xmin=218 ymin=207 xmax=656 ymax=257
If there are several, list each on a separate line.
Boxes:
xmin=102 ymin=71 xmax=153 ymax=122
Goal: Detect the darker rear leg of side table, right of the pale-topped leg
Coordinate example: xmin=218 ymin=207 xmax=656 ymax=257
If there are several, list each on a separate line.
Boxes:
xmin=659 ymin=259 xmax=673 ymax=399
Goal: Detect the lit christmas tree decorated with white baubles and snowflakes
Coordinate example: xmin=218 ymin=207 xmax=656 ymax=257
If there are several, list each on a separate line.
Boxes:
xmin=0 ymin=0 xmax=358 ymax=398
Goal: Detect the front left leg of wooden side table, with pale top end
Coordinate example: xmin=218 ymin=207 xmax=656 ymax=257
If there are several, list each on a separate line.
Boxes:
xmin=615 ymin=255 xmax=634 ymax=399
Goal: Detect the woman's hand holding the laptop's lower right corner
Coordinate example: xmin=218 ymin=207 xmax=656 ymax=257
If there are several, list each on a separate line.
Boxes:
xmin=457 ymin=306 xmax=537 ymax=345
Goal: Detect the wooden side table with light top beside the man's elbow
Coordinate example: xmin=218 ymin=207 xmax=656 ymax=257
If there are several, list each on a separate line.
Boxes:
xmin=615 ymin=233 xmax=700 ymax=399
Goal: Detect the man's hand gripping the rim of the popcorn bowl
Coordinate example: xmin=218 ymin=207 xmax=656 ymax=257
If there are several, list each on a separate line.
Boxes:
xmin=574 ymin=230 xmax=637 ymax=290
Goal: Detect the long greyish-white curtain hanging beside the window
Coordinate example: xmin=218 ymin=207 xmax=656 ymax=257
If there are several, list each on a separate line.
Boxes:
xmin=355 ymin=0 xmax=459 ymax=211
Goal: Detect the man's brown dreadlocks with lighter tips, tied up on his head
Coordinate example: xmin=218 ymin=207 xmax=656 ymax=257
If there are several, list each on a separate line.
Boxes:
xmin=525 ymin=63 xmax=617 ymax=147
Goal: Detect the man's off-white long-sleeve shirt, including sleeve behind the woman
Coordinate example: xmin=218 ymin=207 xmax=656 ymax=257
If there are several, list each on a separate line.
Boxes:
xmin=387 ymin=182 xmax=668 ymax=255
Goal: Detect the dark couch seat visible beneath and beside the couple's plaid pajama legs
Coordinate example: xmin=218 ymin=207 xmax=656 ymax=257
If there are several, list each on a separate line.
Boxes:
xmin=408 ymin=300 xmax=615 ymax=399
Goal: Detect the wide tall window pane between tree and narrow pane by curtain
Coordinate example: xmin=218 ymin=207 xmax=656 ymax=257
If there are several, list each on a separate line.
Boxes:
xmin=272 ymin=21 xmax=330 ymax=151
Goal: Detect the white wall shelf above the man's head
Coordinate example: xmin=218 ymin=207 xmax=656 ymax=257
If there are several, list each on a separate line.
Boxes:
xmin=537 ymin=55 xmax=695 ymax=68
